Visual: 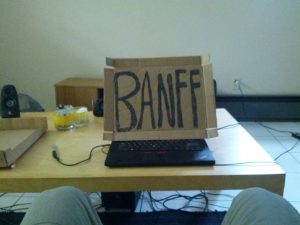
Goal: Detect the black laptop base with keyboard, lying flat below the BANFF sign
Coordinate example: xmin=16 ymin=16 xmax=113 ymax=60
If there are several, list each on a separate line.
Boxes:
xmin=105 ymin=139 xmax=215 ymax=167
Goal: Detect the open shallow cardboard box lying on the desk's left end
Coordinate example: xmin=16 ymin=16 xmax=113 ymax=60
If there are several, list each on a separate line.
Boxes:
xmin=0 ymin=117 xmax=47 ymax=167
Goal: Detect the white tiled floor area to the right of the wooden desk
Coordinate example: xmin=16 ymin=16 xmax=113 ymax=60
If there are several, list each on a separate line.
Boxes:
xmin=242 ymin=122 xmax=300 ymax=212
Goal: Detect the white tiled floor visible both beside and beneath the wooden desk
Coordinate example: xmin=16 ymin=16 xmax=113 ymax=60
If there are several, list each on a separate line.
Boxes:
xmin=0 ymin=122 xmax=300 ymax=212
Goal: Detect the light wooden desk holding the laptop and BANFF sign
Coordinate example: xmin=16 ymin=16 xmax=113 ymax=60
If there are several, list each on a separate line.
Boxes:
xmin=0 ymin=109 xmax=285 ymax=195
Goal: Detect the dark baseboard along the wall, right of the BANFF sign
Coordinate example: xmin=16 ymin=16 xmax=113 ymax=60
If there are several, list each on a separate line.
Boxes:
xmin=216 ymin=96 xmax=300 ymax=121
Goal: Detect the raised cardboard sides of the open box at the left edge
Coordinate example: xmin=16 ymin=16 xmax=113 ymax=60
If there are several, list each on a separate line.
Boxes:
xmin=0 ymin=117 xmax=48 ymax=167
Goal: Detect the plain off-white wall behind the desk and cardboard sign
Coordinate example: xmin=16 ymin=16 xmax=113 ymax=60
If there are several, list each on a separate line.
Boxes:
xmin=0 ymin=0 xmax=300 ymax=110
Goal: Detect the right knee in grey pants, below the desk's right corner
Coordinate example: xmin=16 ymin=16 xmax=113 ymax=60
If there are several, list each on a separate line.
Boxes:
xmin=222 ymin=188 xmax=300 ymax=225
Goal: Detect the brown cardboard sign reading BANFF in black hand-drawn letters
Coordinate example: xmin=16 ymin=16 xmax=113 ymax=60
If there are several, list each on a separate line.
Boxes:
xmin=104 ymin=56 xmax=217 ymax=140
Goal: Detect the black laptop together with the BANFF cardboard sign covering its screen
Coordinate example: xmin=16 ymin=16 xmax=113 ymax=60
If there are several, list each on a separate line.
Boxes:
xmin=103 ymin=56 xmax=218 ymax=167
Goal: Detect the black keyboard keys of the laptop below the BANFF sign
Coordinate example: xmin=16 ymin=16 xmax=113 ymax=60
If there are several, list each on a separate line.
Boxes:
xmin=112 ymin=139 xmax=204 ymax=151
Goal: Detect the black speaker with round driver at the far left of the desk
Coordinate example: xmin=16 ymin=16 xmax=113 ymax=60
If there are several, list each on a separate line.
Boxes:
xmin=1 ymin=84 xmax=20 ymax=118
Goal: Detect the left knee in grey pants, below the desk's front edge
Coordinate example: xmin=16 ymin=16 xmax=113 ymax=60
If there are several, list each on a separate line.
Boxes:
xmin=21 ymin=187 xmax=102 ymax=225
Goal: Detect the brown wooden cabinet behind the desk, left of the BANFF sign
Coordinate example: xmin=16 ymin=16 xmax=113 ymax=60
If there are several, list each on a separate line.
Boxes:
xmin=55 ymin=77 xmax=104 ymax=110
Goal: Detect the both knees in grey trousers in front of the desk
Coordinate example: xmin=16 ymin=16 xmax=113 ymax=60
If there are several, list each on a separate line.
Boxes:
xmin=21 ymin=187 xmax=300 ymax=225
